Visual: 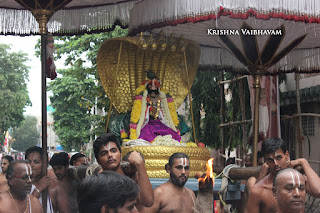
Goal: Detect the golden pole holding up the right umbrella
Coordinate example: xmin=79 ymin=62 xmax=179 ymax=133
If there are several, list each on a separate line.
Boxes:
xmin=252 ymin=75 xmax=261 ymax=166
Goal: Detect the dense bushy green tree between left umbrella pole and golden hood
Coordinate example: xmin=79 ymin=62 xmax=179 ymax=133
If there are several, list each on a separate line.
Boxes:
xmin=48 ymin=68 xmax=94 ymax=150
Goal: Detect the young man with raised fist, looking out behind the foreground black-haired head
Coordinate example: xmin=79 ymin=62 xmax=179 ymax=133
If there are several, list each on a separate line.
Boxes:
xmin=93 ymin=133 xmax=153 ymax=210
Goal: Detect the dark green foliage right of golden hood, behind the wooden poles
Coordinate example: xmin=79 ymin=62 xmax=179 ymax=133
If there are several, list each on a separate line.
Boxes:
xmin=191 ymin=70 xmax=251 ymax=149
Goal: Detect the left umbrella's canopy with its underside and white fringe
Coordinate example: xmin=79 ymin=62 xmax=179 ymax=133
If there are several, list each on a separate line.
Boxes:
xmin=0 ymin=0 xmax=137 ymax=35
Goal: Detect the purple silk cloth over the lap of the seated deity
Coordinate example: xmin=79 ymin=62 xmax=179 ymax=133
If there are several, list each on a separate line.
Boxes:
xmin=139 ymin=120 xmax=181 ymax=142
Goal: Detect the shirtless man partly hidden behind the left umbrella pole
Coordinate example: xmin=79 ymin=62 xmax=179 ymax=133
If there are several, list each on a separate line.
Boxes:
xmin=25 ymin=146 xmax=69 ymax=213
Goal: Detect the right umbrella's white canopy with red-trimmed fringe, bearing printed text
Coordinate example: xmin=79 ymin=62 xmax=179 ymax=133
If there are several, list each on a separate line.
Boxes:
xmin=129 ymin=0 xmax=320 ymax=74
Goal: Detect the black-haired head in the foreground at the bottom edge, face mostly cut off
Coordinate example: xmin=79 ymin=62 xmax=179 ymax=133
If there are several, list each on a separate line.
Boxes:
xmin=78 ymin=171 xmax=139 ymax=213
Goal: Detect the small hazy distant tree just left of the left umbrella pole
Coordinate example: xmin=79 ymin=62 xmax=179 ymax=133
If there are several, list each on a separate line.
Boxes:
xmin=11 ymin=115 xmax=40 ymax=152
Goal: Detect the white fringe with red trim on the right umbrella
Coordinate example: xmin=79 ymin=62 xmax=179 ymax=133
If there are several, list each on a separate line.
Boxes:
xmin=129 ymin=0 xmax=320 ymax=35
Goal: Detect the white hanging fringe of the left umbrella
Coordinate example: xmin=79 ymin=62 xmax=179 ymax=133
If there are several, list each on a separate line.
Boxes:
xmin=0 ymin=1 xmax=135 ymax=35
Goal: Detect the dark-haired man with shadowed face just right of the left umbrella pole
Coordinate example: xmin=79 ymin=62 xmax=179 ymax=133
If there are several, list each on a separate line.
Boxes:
xmin=50 ymin=152 xmax=78 ymax=212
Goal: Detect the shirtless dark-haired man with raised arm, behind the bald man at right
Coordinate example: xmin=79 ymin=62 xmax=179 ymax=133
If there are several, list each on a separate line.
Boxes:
xmin=246 ymin=138 xmax=320 ymax=213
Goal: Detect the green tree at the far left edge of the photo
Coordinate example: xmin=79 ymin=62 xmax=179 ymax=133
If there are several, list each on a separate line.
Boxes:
xmin=0 ymin=44 xmax=31 ymax=143
